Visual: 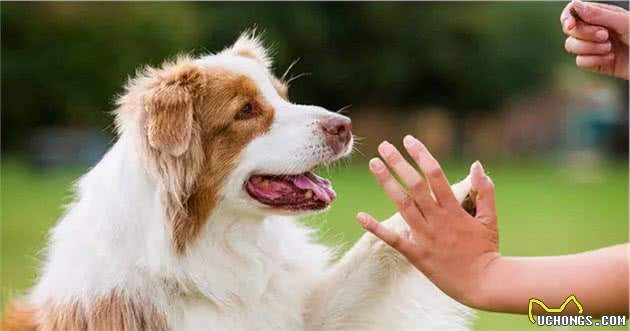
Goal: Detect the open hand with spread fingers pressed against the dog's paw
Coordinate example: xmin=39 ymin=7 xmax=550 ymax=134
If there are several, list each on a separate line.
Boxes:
xmin=357 ymin=136 xmax=499 ymax=307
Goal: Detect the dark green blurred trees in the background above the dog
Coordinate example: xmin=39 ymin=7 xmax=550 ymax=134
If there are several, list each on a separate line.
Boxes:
xmin=1 ymin=2 xmax=571 ymax=148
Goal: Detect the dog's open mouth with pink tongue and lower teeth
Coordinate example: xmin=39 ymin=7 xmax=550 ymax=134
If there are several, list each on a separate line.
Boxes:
xmin=245 ymin=172 xmax=336 ymax=210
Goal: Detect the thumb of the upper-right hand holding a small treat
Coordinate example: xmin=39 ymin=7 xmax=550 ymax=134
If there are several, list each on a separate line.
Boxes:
xmin=573 ymin=0 xmax=630 ymax=35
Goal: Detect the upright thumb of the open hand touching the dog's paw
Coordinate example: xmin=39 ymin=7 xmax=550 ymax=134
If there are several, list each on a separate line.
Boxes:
xmin=470 ymin=161 xmax=497 ymax=226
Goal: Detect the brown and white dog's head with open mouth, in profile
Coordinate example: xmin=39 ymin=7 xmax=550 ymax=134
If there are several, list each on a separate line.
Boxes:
xmin=117 ymin=34 xmax=353 ymax=250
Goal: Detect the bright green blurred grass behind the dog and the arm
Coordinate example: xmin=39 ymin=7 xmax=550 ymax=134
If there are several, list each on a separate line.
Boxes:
xmin=0 ymin=157 xmax=628 ymax=330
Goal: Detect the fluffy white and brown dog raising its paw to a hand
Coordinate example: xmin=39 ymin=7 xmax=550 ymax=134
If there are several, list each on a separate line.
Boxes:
xmin=3 ymin=33 xmax=472 ymax=331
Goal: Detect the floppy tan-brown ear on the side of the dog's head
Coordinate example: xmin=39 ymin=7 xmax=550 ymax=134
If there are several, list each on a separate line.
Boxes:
xmin=144 ymin=60 xmax=205 ymax=157
